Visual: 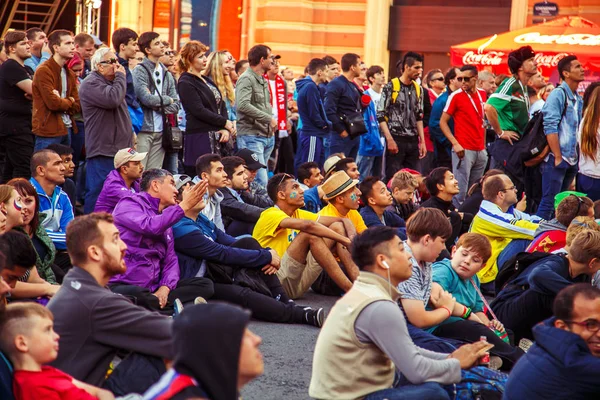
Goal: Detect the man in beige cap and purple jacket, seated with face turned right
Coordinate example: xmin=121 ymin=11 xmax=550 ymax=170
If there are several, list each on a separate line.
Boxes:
xmin=94 ymin=148 xmax=147 ymax=214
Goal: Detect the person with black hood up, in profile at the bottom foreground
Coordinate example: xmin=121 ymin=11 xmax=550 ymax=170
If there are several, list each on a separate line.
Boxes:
xmin=144 ymin=304 xmax=264 ymax=400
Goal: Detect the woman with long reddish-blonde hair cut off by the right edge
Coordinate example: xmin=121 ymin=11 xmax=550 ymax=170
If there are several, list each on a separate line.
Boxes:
xmin=577 ymin=82 xmax=600 ymax=201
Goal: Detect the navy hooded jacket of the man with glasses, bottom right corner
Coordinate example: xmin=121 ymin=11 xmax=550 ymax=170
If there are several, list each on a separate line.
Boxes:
xmin=503 ymin=317 xmax=600 ymax=400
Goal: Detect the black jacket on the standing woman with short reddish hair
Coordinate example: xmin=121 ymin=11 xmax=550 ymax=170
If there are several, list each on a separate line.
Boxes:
xmin=177 ymin=72 xmax=227 ymax=134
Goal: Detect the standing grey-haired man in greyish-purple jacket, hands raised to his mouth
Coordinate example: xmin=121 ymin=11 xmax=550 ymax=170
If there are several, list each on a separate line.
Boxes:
xmin=80 ymin=47 xmax=133 ymax=214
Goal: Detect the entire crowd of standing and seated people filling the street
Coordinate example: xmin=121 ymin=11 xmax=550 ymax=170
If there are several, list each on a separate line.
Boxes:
xmin=0 ymin=24 xmax=600 ymax=400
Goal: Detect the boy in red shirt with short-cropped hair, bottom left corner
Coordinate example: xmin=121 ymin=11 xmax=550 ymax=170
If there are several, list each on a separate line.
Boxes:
xmin=0 ymin=303 xmax=115 ymax=400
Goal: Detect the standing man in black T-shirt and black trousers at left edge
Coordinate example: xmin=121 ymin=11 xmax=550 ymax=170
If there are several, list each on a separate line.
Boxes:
xmin=0 ymin=31 xmax=33 ymax=182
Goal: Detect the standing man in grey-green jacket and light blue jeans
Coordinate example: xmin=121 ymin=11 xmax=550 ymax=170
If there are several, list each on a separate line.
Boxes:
xmin=235 ymin=44 xmax=278 ymax=187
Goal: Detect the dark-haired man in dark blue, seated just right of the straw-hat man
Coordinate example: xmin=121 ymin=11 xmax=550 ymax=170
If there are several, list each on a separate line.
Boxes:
xmin=359 ymin=176 xmax=406 ymax=240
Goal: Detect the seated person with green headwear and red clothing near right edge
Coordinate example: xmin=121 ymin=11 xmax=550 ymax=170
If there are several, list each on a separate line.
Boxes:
xmin=527 ymin=192 xmax=594 ymax=253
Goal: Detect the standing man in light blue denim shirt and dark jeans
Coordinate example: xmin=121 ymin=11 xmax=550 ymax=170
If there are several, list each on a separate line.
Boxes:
xmin=537 ymin=56 xmax=585 ymax=221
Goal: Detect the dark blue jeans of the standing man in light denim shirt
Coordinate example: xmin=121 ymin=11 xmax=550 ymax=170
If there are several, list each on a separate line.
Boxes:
xmin=537 ymin=154 xmax=578 ymax=221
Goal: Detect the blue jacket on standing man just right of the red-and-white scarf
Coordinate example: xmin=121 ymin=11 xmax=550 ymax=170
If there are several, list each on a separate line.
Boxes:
xmin=296 ymin=76 xmax=332 ymax=137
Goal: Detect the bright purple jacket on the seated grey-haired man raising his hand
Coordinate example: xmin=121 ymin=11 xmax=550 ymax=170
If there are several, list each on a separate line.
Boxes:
xmin=110 ymin=192 xmax=184 ymax=292
